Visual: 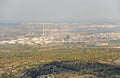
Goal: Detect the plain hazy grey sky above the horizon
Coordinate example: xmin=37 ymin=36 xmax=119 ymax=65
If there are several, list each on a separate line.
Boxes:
xmin=0 ymin=0 xmax=120 ymax=22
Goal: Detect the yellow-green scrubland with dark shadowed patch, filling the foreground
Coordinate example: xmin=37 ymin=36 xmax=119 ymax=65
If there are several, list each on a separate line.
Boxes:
xmin=0 ymin=45 xmax=120 ymax=78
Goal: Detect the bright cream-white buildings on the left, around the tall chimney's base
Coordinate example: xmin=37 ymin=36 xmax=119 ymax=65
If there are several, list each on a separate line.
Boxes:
xmin=0 ymin=37 xmax=52 ymax=45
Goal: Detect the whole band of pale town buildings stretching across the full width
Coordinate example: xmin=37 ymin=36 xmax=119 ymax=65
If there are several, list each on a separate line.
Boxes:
xmin=0 ymin=32 xmax=120 ymax=45
